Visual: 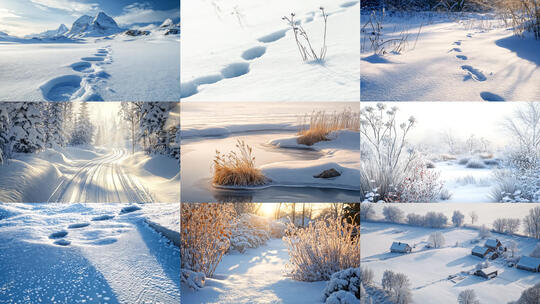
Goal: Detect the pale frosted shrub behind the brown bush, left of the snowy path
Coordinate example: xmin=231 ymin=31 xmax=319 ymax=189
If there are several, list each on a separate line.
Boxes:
xmin=229 ymin=213 xmax=270 ymax=253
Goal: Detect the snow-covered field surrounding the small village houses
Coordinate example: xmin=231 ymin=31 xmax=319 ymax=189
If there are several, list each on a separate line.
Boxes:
xmin=360 ymin=221 xmax=540 ymax=303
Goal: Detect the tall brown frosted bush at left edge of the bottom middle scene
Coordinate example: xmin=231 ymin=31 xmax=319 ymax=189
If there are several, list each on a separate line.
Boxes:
xmin=180 ymin=203 xmax=234 ymax=277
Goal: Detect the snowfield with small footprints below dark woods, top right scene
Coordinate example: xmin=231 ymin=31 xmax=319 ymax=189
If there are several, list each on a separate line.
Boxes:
xmin=360 ymin=12 xmax=540 ymax=101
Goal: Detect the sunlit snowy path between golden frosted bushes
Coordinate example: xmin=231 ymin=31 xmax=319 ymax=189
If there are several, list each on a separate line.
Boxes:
xmin=181 ymin=239 xmax=326 ymax=304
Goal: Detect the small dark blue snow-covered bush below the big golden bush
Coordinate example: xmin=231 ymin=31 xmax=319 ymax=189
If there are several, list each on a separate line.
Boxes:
xmin=323 ymin=267 xmax=361 ymax=304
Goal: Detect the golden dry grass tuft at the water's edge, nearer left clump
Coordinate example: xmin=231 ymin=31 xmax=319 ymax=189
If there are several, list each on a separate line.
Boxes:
xmin=212 ymin=140 xmax=268 ymax=186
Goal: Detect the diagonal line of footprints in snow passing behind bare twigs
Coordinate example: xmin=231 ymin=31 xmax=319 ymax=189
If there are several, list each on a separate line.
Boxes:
xmin=180 ymin=1 xmax=359 ymax=98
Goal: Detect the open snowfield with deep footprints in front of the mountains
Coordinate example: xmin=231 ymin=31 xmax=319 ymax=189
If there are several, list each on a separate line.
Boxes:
xmin=0 ymin=16 xmax=180 ymax=101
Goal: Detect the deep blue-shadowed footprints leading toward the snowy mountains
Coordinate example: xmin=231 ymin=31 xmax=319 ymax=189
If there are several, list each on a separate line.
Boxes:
xmin=40 ymin=45 xmax=113 ymax=101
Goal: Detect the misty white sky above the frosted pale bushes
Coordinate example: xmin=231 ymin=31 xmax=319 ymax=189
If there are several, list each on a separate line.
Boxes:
xmin=360 ymin=102 xmax=523 ymax=147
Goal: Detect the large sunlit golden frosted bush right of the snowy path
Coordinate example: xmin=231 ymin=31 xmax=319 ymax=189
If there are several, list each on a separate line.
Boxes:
xmin=283 ymin=219 xmax=360 ymax=282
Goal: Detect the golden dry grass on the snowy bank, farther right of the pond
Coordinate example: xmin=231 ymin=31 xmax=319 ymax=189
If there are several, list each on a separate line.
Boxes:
xmin=297 ymin=108 xmax=360 ymax=146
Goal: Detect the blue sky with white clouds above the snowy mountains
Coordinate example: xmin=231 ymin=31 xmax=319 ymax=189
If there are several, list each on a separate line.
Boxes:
xmin=0 ymin=0 xmax=180 ymax=36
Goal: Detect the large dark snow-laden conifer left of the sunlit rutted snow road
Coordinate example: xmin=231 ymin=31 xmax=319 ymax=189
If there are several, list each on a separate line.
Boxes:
xmin=9 ymin=102 xmax=45 ymax=153
